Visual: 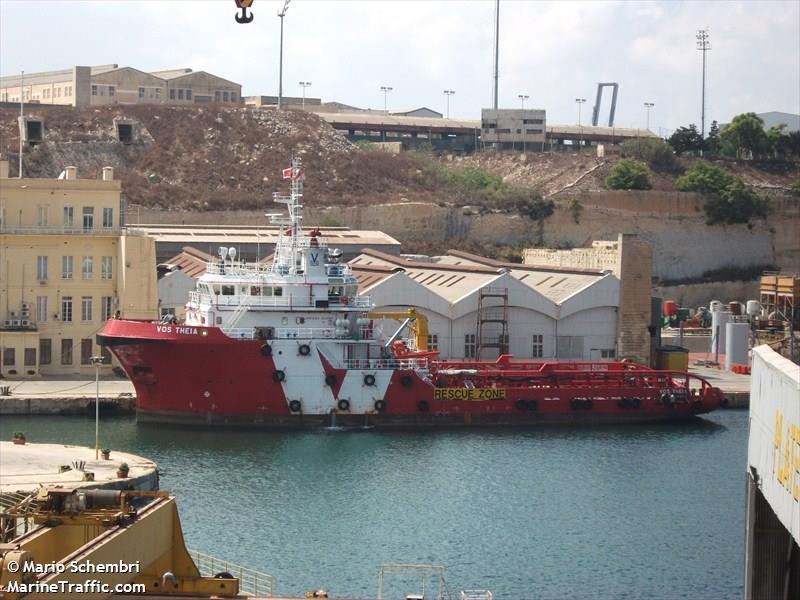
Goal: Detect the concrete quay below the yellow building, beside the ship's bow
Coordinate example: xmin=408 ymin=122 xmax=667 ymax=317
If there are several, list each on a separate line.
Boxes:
xmin=0 ymin=378 xmax=136 ymax=415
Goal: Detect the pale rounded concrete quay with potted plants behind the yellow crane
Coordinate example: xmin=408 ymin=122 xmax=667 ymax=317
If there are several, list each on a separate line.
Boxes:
xmin=0 ymin=442 xmax=158 ymax=495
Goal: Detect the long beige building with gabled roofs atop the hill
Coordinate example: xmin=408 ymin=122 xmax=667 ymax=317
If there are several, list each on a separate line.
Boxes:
xmin=0 ymin=64 xmax=242 ymax=106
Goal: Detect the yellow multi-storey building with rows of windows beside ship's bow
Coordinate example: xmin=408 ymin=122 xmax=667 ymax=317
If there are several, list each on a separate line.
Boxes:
xmin=0 ymin=161 xmax=158 ymax=377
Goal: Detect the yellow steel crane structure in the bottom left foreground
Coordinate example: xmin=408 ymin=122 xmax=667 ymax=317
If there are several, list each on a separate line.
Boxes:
xmin=0 ymin=488 xmax=239 ymax=600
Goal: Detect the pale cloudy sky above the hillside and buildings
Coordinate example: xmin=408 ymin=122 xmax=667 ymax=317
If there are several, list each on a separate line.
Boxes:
xmin=0 ymin=0 xmax=800 ymax=135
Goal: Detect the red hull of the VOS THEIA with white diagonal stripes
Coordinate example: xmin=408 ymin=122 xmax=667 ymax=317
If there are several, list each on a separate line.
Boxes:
xmin=98 ymin=320 xmax=723 ymax=429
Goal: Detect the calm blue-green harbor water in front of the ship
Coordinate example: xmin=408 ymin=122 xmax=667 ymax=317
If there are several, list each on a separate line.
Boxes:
xmin=0 ymin=410 xmax=748 ymax=599
